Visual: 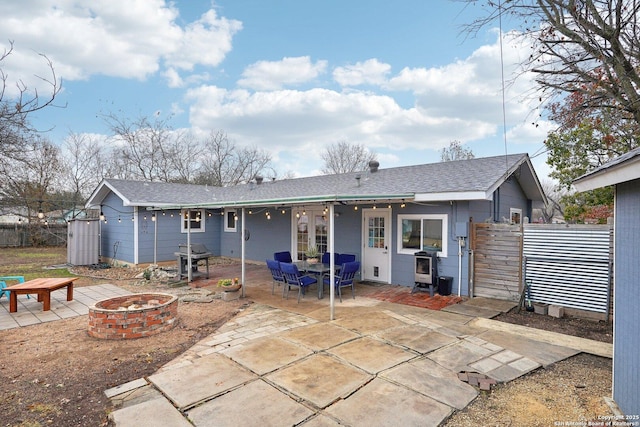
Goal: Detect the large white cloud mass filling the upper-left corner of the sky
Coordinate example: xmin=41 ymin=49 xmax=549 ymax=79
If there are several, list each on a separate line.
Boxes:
xmin=0 ymin=0 xmax=242 ymax=84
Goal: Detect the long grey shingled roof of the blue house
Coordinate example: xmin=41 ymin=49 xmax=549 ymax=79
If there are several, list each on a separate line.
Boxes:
xmin=87 ymin=154 xmax=546 ymax=208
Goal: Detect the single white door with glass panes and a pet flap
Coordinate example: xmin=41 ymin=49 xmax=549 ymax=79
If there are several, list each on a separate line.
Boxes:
xmin=361 ymin=208 xmax=391 ymax=283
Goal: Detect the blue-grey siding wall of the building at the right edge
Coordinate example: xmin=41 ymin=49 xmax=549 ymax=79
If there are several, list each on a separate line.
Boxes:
xmin=613 ymin=180 xmax=640 ymax=415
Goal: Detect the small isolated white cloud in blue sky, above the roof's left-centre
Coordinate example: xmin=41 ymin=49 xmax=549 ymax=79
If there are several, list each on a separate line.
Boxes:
xmin=238 ymin=56 xmax=327 ymax=90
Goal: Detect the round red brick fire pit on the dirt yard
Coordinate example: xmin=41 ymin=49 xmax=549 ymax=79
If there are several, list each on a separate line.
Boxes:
xmin=89 ymin=293 xmax=178 ymax=340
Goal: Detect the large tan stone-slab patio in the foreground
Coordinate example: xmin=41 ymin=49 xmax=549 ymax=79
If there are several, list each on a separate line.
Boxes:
xmin=106 ymin=298 xmax=592 ymax=426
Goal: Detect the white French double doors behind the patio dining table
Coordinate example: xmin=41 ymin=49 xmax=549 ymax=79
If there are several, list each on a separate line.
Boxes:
xmin=291 ymin=209 xmax=329 ymax=261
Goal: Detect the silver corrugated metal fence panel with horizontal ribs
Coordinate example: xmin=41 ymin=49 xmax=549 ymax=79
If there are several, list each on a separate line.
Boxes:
xmin=523 ymin=224 xmax=612 ymax=313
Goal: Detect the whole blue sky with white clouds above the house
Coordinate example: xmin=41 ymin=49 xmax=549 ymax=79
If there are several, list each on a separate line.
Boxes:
xmin=0 ymin=0 xmax=550 ymax=179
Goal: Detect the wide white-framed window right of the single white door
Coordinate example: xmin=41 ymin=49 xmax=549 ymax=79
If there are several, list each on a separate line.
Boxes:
xmin=398 ymin=214 xmax=448 ymax=257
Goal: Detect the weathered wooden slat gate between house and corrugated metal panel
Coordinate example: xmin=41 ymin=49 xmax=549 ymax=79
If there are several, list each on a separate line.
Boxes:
xmin=470 ymin=223 xmax=523 ymax=301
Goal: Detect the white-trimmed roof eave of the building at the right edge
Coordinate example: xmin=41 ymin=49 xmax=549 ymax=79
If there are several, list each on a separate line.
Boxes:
xmin=573 ymin=147 xmax=640 ymax=191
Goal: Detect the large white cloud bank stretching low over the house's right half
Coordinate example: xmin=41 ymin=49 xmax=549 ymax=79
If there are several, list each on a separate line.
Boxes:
xmin=181 ymin=30 xmax=547 ymax=175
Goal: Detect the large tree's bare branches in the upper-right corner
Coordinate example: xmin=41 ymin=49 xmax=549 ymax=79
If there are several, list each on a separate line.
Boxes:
xmin=459 ymin=0 xmax=640 ymax=123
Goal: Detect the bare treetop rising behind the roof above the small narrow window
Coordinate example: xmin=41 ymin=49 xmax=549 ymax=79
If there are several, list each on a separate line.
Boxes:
xmin=196 ymin=130 xmax=271 ymax=187
